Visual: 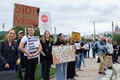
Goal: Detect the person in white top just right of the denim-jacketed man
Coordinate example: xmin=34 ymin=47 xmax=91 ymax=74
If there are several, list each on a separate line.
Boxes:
xmin=106 ymin=38 xmax=113 ymax=69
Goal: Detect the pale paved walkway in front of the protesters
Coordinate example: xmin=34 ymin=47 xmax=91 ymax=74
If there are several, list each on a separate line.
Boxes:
xmin=51 ymin=58 xmax=112 ymax=80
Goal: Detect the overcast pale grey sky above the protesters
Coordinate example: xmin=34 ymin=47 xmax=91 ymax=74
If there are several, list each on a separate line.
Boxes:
xmin=0 ymin=0 xmax=120 ymax=34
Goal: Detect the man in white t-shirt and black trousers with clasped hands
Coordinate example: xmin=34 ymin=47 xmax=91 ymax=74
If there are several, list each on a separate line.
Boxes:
xmin=19 ymin=27 xmax=42 ymax=80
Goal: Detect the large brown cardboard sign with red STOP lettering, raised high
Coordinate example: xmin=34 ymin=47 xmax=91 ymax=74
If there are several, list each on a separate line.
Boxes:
xmin=13 ymin=4 xmax=40 ymax=27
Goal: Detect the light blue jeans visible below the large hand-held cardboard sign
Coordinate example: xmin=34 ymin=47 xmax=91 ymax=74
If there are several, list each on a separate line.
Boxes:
xmin=56 ymin=63 xmax=67 ymax=80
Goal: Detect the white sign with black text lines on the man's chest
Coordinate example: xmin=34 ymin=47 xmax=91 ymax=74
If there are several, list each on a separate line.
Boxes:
xmin=27 ymin=36 xmax=40 ymax=59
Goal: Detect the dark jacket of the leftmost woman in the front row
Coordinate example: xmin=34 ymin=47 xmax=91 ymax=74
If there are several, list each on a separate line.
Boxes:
xmin=0 ymin=40 xmax=19 ymax=65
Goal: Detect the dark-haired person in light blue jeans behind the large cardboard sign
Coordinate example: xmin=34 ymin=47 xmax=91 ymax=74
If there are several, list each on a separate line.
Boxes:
xmin=55 ymin=33 xmax=67 ymax=80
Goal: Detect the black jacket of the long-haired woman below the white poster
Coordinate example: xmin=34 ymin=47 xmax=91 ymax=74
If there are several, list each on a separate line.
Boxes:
xmin=40 ymin=41 xmax=53 ymax=62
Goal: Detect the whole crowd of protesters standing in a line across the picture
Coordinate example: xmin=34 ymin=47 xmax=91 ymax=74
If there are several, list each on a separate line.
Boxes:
xmin=0 ymin=27 xmax=120 ymax=80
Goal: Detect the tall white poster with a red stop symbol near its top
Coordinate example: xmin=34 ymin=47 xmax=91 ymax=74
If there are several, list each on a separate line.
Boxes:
xmin=39 ymin=12 xmax=53 ymax=35
